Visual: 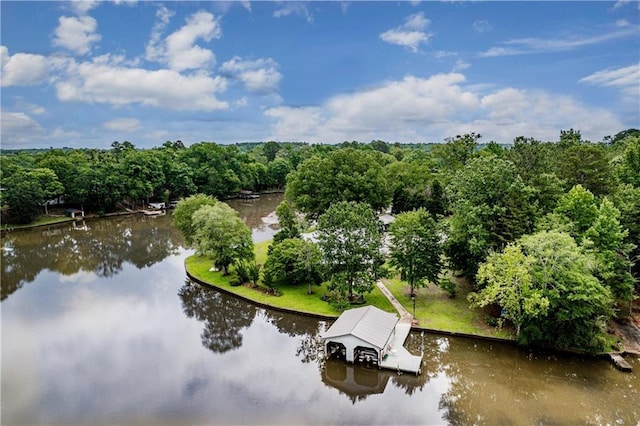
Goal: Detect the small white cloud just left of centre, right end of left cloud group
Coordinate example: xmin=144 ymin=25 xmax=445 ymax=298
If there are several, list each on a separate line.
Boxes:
xmin=220 ymin=56 xmax=282 ymax=93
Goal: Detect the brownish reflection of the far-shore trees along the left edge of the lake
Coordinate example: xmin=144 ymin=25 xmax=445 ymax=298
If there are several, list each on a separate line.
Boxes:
xmin=0 ymin=215 xmax=182 ymax=300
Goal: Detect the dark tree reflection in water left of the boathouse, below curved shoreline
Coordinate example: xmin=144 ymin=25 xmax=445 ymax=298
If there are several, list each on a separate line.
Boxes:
xmin=178 ymin=280 xmax=257 ymax=353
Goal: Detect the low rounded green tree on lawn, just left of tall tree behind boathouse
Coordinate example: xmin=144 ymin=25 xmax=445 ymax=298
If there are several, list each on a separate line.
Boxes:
xmin=264 ymin=238 xmax=323 ymax=294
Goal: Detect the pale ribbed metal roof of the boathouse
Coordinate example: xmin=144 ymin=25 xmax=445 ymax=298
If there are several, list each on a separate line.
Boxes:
xmin=322 ymin=306 xmax=398 ymax=348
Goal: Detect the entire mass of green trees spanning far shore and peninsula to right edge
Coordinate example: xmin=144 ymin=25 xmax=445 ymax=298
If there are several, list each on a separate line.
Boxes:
xmin=2 ymin=129 xmax=640 ymax=349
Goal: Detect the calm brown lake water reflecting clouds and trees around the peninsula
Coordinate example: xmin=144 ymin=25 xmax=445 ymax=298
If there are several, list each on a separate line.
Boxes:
xmin=0 ymin=196 xmax=640 ymax=425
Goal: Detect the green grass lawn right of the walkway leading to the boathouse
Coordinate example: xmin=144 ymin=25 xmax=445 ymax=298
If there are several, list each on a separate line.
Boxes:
xmin=382 ymin=272 xmax=512 ymax=339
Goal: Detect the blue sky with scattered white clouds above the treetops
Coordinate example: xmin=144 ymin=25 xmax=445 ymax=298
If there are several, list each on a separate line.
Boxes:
xmin=0 ymin=0 xmax=640 ymax=149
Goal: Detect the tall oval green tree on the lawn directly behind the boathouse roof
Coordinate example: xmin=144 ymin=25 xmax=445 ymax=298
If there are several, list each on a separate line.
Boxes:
xmin=318 ymin=201 xmax=382 ymax=302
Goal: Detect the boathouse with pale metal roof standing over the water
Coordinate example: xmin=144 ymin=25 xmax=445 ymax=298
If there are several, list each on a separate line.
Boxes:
xmin=321 ymin=306 xmax=398 ymax=365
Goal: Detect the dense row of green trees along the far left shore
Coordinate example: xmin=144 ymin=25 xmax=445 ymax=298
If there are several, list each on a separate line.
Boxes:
xmin=0 ymin=141 xmax=312 ymax=223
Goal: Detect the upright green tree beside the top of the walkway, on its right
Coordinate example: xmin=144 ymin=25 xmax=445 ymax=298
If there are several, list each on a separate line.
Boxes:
xmin=389 ymin=209 xmax=442 ymax=296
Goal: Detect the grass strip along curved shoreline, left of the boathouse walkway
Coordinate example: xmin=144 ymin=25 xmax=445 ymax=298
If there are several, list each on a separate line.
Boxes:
xmin=185 ymin=241 xmax=395 ymax=316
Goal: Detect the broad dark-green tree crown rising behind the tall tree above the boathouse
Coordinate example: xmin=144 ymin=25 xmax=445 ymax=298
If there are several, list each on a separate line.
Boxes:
xmin=286 ymin=148 xmax=392 ymax=218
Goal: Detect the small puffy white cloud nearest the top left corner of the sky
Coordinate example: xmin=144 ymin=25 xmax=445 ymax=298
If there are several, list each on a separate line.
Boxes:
xmin=53 ymin=16 xmax=101 ymax=55
